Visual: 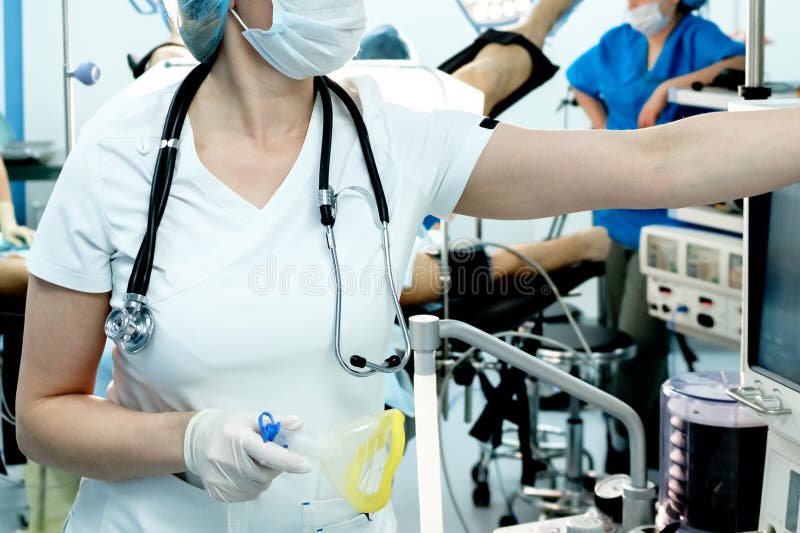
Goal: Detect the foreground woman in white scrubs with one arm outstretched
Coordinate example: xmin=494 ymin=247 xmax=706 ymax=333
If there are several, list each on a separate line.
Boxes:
xmin=12 ymin=0 xmax=800 ymax=533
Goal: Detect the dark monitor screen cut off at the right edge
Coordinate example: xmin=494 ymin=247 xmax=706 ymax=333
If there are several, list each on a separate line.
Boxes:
xmin=748 ymin=184 xmax=800 ymax=390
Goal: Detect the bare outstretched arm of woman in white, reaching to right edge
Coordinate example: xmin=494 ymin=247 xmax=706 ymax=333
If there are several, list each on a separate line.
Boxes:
xmin=456 ymin=109 xmax=800 ymax=219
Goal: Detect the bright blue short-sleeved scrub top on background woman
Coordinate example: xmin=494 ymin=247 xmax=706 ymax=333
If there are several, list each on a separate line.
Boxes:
xmin=567 ymin=15 xmax=745 ymax=250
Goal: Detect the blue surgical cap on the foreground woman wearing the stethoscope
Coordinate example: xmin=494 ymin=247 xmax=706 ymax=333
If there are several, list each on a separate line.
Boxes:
xmin=176 ymin=0 xmax=231 ymax=63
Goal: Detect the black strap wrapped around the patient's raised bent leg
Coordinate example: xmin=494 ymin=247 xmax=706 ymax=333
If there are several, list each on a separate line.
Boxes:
xmin=439 ymin=30 xmax=558 ymax=118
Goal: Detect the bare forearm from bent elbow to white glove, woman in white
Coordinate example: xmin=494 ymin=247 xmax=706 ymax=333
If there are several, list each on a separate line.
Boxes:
xmin=17 ymin=394 xmax=193 ymax=481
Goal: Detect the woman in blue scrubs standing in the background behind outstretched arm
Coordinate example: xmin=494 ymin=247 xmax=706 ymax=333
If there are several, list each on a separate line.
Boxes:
xmin=567 ymin=0 xmax=745 ymax=472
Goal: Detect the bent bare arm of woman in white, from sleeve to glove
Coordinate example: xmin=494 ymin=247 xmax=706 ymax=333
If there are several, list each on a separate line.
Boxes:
xmin=16 ymin=276 xmax=191 ymax=480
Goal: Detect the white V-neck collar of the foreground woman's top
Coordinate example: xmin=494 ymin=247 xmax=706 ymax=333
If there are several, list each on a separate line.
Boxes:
xmin=179 ymin=94 xmax=322 ymax=218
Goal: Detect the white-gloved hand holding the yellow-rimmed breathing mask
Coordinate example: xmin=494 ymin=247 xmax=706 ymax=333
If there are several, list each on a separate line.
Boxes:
xmin=183 ymin=409 xmax=311 ymax=502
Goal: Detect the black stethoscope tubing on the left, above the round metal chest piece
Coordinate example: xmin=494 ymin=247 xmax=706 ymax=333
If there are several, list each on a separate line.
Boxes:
xmin=128 ymin=63 xmax=211 ymax=295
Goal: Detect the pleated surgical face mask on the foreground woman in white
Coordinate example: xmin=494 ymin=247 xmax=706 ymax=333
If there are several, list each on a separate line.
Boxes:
xmin=231 ymin=0 xmax=367 ymax=80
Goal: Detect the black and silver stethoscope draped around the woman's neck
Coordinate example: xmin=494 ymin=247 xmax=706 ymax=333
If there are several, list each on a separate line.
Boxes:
xmin=105 ymin=64 xmax=411 ymax=377
